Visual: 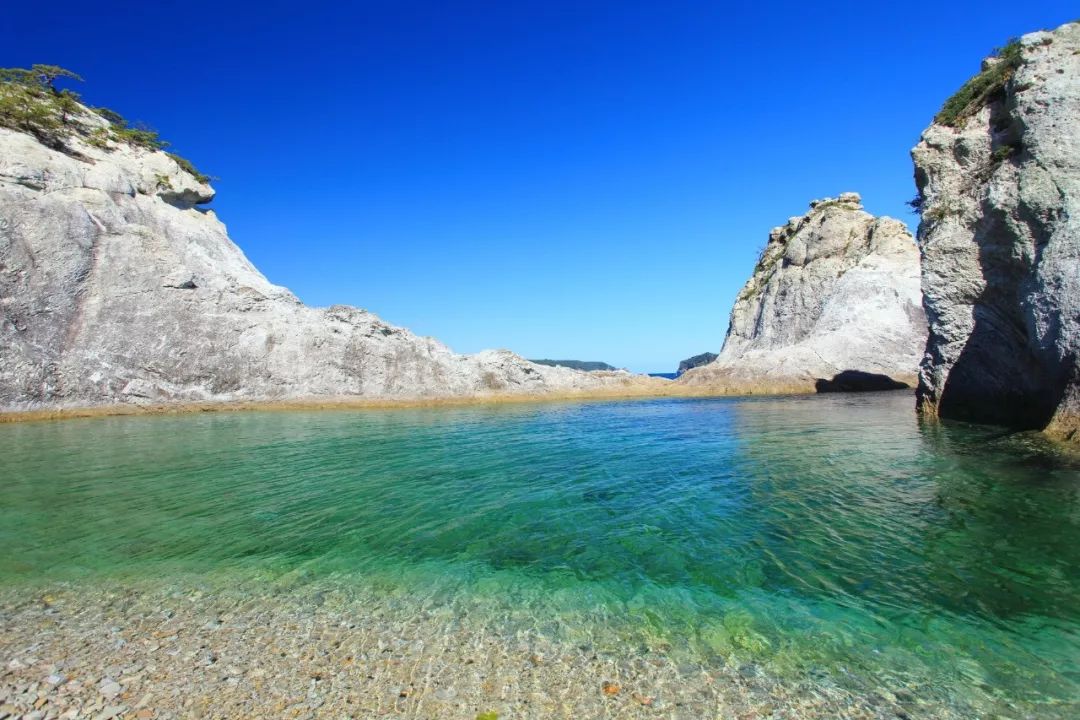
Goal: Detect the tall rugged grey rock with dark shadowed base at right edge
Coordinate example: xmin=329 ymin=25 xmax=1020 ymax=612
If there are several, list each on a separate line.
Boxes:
xmin=912 ymin=23 xmax=1080 ymax=439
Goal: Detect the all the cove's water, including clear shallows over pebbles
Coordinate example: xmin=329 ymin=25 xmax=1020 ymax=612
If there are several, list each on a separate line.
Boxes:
xmin=0 ymin=392 xmax=1080 ymax=718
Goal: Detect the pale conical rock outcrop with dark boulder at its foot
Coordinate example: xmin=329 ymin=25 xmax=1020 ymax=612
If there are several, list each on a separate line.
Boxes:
xmin=678 ymin=192 xmax=926 ymax=393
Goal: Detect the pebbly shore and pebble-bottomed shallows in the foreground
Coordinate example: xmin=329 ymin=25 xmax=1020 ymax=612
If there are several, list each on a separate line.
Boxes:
xmin=0 ymin=582 xmax=962 ymax=720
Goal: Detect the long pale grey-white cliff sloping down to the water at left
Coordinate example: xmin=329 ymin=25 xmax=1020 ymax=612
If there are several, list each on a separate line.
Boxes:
xmin=0 ymin=116 xmax=642 ymax=410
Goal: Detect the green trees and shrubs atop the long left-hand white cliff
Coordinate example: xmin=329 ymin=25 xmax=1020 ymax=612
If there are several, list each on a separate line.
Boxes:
xmin=0 ymin=65 xmax=211 ymax=187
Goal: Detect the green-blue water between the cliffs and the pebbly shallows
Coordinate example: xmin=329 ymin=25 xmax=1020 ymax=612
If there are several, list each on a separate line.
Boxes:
xmin=0 ymin=393 xmax=1080 ymax=717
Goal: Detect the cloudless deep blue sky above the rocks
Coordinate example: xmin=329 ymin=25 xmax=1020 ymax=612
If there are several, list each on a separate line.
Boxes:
xmin=0 ymin=0 xmax=1080 ymax=371
